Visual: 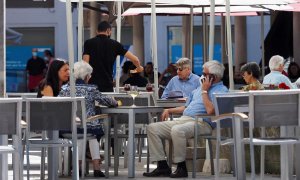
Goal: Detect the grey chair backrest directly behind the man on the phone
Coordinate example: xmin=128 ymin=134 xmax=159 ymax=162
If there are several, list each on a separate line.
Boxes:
xmin=213 ymin=91 xmax=249 ymax=127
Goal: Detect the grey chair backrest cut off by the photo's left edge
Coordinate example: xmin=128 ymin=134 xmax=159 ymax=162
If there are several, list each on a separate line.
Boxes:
xmin=0 ymin=98 xmax=22 ymax=135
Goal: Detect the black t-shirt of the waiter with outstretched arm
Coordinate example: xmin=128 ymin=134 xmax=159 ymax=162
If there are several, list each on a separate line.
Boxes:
xmin=83 ymin=35 xmax=127 ymax=92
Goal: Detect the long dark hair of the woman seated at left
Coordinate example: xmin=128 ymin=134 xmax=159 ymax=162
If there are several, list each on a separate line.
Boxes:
xmin=39 ymin=59 xmax=67 ymax=96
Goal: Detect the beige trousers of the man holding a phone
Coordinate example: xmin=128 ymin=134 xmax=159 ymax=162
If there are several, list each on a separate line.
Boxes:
xmin=147 ymin=116 xmax=212 ymax=163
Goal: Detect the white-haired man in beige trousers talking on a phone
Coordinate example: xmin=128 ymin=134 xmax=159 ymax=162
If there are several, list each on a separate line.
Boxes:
xmin=143 ymin=61 xmax=228 ymax=178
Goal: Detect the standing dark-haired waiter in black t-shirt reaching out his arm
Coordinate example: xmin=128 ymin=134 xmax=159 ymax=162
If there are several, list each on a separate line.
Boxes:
xmin=83 ymin=21 xmax=144 ymax=92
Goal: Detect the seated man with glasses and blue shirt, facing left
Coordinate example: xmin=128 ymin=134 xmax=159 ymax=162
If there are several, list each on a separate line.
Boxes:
xmin=161 ymin=58 xmax=200 ymax=99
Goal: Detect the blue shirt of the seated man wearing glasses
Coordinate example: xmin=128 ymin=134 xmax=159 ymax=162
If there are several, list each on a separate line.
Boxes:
xmin=161 ymin=73 xmax=200 ymax=99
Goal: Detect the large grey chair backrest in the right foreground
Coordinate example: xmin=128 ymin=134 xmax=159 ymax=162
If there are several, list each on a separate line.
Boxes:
xmin=249 ymin=89 xmax=300 ymax=128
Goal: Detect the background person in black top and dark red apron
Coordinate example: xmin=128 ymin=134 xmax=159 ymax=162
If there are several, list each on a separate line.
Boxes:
xmin=26 ymin=48 xmax=46 ymax=92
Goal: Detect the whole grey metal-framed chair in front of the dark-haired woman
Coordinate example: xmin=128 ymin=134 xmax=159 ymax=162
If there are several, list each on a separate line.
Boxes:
xmin=25 ymin=97 xmax=79 ymax=180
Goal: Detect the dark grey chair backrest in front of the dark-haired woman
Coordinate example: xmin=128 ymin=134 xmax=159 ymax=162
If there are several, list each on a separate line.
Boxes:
xmin=25 ymin=97 xmax=76 ymax=131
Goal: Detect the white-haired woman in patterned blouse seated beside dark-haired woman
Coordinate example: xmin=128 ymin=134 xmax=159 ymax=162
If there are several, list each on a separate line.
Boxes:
xmin=60 ymin=61 xmax=118 ymax=177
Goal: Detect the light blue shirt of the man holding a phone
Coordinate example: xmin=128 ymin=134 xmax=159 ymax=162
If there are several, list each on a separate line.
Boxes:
xmin=183 ymin=81 xmax=228 ymax=127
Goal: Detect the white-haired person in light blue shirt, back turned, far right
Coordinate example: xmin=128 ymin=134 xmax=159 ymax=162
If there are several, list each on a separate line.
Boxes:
xmin=263 ymin=55 xmax=295 ymax=89
